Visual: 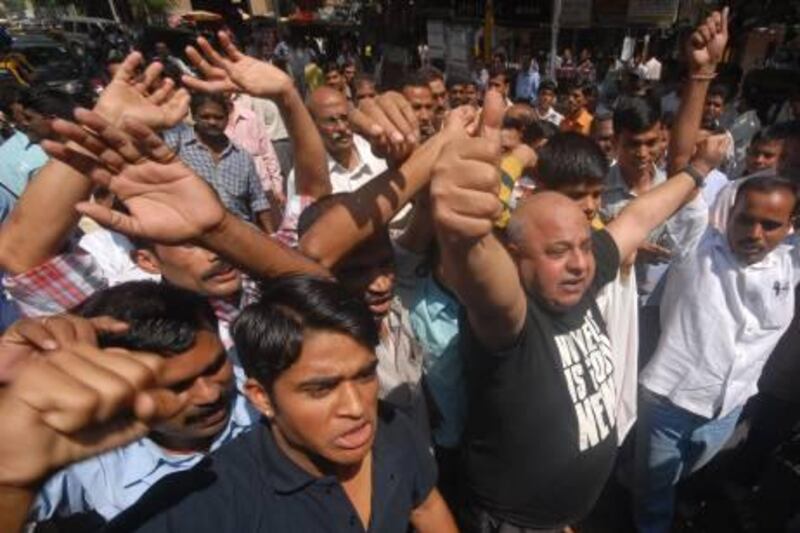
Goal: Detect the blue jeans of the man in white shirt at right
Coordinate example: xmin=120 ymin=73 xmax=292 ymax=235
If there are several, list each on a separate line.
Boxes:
xmin=634 ymin=388 xmax=742 ymax=533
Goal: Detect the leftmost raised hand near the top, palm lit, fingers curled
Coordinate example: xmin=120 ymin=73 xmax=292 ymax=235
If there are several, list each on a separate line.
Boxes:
xmin=94 ymin=52 xmax=189 ymax=130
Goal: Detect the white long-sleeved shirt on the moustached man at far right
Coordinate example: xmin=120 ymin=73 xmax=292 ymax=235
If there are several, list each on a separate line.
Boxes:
xmin=639 ymin=191 xmax=800 ymax=418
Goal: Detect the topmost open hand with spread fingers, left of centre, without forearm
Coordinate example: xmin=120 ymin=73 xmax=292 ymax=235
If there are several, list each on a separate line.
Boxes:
xmin=182 ymin=31 xmax=293 ymax=99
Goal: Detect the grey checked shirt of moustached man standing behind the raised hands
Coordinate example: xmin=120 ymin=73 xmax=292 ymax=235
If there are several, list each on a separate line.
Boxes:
xmin=164 ymin=124 xmax=269 ymax=222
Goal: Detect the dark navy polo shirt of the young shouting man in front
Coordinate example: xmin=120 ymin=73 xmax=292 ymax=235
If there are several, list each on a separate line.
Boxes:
xmin=108 ymin=404 xmax=436 ymax=533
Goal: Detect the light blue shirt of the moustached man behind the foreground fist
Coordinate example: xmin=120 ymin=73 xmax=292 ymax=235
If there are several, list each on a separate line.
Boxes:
xmin=29 ymin=394 xmax=255 ymax=521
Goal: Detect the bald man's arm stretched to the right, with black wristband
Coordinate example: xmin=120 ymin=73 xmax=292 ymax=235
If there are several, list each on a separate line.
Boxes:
xmin=606 ymin=134 xmax=730 ymax=257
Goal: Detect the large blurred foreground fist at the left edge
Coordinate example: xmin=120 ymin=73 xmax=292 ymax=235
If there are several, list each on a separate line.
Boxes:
xmin=0 ymin=344 xmax=203 ymax=489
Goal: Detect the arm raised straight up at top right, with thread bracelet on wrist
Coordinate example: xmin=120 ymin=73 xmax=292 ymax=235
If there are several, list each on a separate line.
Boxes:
xmin=667 ymin=7 xmax=728 ymax=175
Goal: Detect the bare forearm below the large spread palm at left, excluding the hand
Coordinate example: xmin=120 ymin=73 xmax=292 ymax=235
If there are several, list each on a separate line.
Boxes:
xmin=199 ymin=213 xmax=330 ymax=278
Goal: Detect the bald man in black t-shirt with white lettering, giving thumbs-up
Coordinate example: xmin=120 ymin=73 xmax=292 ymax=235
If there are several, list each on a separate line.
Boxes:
xmin=431 ymin=133 xmax=722 ymax=532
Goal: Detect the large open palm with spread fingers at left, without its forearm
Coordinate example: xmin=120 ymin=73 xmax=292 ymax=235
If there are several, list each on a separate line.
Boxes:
xmin=42 ymin=110 xmax=227 ymax=244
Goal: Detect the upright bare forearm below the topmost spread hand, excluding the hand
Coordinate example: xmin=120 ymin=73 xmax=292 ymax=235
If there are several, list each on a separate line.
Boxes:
xmin=275 ymin=86 xmax=331 ymax=198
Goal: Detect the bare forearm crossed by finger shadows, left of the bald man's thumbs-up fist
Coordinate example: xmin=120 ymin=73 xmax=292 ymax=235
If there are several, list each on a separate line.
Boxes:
xmin=300 ymin=133 xmax=446 ymax=268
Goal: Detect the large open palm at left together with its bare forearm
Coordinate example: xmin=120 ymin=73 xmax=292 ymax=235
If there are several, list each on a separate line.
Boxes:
xmin=45 ymin=112 xmax=327 ymax=277
